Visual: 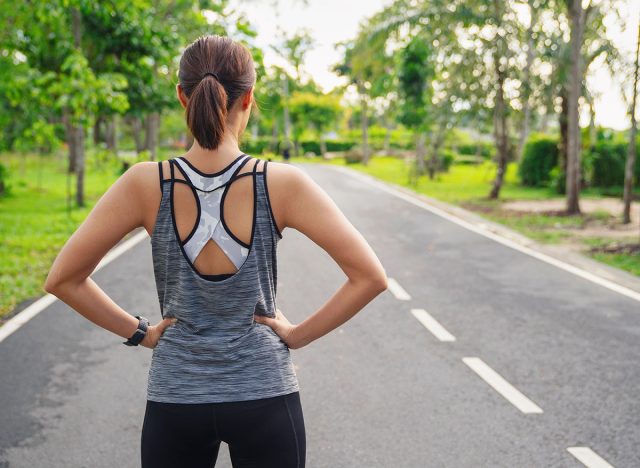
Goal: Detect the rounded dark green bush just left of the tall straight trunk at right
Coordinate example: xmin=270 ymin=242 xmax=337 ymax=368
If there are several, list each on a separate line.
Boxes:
xmin=518 ymin=135 xmax=558 ymax=187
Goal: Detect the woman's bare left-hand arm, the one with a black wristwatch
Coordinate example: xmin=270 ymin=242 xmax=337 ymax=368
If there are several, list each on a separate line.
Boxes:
xmin=44 ymin=163 xmax=175 ymax=347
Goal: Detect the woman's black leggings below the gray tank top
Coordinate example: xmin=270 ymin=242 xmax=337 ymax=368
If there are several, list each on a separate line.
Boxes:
xmin=141 ymin=392 xmax=306 ymax=468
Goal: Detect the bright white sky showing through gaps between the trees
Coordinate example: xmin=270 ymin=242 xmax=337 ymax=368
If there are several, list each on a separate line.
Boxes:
xmin=230 ymin=0 xmax=640 ymax=129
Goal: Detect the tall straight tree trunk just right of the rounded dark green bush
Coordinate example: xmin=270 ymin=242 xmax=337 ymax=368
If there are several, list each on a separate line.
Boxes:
xmin=567 ymin=0 xmax=584 ymax=214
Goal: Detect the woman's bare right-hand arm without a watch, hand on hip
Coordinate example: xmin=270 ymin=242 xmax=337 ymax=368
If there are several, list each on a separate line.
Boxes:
xmin=255 ymin=166 xmax=387 ymax=349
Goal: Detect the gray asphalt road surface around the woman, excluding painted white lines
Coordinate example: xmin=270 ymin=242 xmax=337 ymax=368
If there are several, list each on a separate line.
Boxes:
xmin=0 ymin=165 xmax=640 ymax=468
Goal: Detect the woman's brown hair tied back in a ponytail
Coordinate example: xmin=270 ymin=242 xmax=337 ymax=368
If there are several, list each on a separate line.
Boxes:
xmin=178 ymin=35 xmax=256 ymax=149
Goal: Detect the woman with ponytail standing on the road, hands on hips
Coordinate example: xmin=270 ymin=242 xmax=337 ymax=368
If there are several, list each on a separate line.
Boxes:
xmin=45 ymin=36 xmax=387 ymax=468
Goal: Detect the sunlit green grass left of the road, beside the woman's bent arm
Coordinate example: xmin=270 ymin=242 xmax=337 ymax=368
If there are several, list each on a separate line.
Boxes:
xmin=0 ymin=150 xmax=178 ymax=318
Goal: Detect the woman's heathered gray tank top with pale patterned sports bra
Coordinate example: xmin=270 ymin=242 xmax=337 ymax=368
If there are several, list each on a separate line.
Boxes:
xmin=147 ymin=154 xmax=299 ymax=403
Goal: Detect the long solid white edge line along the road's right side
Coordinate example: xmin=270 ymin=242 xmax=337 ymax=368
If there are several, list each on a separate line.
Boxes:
xmin=329 ymin=166 xmax=640 ymax=302
